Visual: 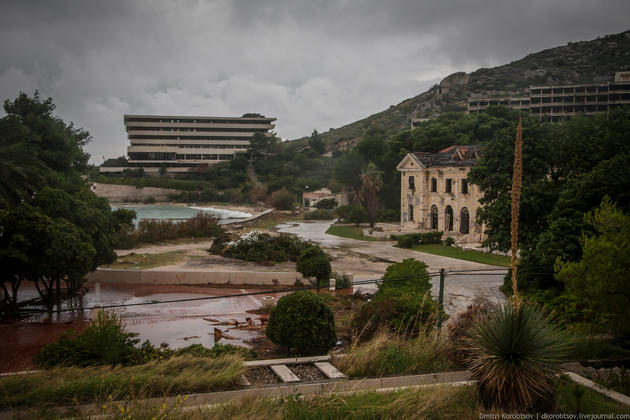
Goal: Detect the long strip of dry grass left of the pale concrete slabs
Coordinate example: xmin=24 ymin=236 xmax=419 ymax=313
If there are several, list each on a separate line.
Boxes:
xmin=0 ymin=355 xmax=244 ymax=408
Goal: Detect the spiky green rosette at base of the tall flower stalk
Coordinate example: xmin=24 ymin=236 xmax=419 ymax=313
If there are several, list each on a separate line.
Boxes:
xmin=468 ymin=303 xmax=569 ymax=411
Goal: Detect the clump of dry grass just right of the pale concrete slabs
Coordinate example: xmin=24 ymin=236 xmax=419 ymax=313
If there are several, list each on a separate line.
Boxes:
xmin=333 ymin=331 xmax=455 ymax=378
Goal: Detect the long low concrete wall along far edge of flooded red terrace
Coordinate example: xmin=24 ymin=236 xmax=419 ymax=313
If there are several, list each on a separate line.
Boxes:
xmin=87 ymin=269 xmax=302 ymax=286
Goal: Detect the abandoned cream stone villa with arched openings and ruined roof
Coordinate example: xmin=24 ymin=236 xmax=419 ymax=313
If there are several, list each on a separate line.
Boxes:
xmin=396 ymin=146 xmax=483 ymax=242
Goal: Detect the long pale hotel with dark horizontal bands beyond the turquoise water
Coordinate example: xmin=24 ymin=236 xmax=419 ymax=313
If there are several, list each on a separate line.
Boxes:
xmin=101 ymin=114 xmax=276 ymax=172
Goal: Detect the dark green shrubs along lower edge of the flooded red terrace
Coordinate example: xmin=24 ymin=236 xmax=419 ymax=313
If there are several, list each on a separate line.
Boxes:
xmin=34 ymin=311 xmax=256 ymax=368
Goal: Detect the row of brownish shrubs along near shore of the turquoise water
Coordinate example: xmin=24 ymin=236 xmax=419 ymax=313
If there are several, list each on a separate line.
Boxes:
xmin=117 ymin=213 xmax=223 ymax=249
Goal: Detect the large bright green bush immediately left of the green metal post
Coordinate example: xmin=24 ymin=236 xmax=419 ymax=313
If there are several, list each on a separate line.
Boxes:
xmin=352 ymin=258 xmax=437 ymax=340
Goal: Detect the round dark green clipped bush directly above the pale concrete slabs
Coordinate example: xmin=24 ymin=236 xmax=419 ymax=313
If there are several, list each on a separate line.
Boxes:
xmin=266 ymin=291 xmax=337 ymax=355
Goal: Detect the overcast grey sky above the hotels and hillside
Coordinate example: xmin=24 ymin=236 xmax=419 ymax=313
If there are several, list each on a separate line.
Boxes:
xmin=0 ymin=0 xmax=630 ymax=164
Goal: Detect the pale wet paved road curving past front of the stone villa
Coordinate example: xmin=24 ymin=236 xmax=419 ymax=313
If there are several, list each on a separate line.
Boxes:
xmin=276 ymin=220 xmax=507 ymax=314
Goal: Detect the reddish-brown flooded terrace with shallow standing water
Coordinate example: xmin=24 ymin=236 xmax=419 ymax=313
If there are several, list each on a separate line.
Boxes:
xmin=0 ymin=284 xmax=285 ymax=372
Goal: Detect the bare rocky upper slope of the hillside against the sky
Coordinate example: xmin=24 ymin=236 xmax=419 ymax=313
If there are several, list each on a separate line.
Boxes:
xmin=297 ymin=31 xmax=630 ymax=150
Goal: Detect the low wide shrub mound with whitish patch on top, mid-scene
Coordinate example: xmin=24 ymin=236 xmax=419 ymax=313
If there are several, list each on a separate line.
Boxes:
xmin=218 ymin=231 xmax=312 ymax=263
